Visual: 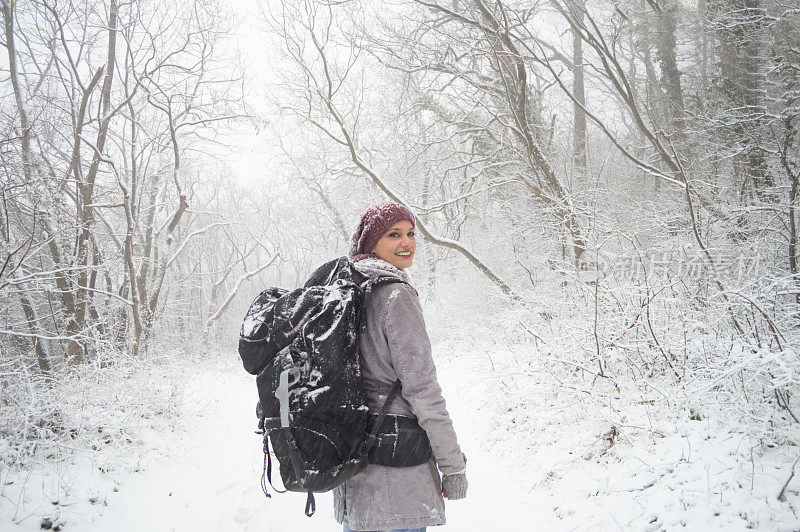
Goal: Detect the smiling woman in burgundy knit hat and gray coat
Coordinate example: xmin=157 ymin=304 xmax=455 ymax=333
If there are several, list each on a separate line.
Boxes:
xmin=334 ymin=203 xmax=467 ymax=532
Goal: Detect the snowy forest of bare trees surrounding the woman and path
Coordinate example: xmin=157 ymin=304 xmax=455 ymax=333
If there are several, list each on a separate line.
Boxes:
xmin=0 ymin=0 xmax=800 ymax=530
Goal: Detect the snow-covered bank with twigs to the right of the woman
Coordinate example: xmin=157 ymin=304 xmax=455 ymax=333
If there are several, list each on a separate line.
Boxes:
xmin=440 ymin=334 xmax=800 ymax=531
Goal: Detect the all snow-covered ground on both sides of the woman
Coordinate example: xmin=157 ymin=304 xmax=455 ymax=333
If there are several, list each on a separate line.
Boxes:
xmin=0 ymin=302 xmax=800 ymax=532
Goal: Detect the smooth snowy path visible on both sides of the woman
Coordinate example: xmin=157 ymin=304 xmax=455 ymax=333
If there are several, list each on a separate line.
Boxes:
xmin=75 ymin=352 xmax=530 ymax=532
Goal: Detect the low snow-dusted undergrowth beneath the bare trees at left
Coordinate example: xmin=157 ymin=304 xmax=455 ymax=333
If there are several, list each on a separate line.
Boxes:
xmin=0 ymin=353 xmax=184 ymax=469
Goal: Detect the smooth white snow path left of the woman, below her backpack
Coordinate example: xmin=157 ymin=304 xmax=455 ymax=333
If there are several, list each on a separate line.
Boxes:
xmin=86 ymin=359 xmax=335 ymax=532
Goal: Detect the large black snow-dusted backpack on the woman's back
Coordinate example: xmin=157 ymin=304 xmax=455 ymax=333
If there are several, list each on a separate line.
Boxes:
xmin=239 ymin=257 xmax=404 ymax=517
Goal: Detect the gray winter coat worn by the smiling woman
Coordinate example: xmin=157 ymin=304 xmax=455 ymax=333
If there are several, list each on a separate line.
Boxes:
xmin=333 ymin=259 xmax=466 ymax=530
